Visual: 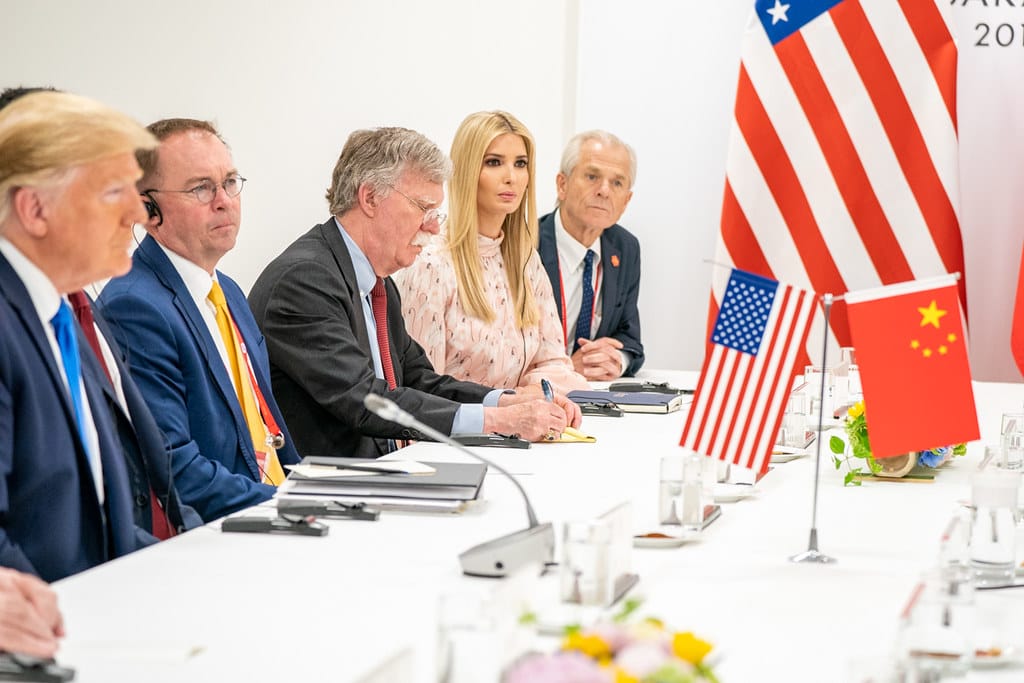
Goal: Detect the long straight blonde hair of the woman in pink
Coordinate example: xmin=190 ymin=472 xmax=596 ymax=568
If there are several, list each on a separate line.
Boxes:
xmin=445 ymin=112 xmax=541 ymax=330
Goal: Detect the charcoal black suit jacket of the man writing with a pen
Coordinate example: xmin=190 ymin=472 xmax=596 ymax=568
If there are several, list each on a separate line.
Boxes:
xmin=243 ymin=218 xmax=490 ymax=458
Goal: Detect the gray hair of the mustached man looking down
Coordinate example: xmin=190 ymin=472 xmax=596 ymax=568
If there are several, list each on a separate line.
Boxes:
xmin=327 ymin=128 xmax=452 ymax=216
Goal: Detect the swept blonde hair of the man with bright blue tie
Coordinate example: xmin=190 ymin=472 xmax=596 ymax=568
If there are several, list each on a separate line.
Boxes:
xmin=0 ymin=92 xmax=157 ymax=223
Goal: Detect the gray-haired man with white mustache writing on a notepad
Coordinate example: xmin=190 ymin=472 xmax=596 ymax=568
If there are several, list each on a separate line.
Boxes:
xmin=249 ymin=128 xmax=580 ymax=458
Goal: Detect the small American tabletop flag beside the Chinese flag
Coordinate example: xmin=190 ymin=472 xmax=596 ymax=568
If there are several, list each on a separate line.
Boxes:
xmin=680 ymin=269 xmax=817 ymax=472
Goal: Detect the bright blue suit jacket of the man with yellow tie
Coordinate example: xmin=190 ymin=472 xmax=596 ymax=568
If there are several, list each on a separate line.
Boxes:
xmin=98 ymin=237 xmax=299 ymax=521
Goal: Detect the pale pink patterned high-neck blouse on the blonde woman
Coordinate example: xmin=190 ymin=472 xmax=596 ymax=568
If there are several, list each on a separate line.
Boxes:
xmin=394 ymin=233 xmax=589 ymax=393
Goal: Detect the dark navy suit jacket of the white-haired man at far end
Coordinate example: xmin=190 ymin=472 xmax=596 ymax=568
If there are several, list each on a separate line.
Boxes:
xmin=538 ymin=213 xmax=644 ymax=375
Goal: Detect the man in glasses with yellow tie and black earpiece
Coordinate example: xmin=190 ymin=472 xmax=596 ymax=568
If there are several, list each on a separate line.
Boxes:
xmin=98 ymin=119 xmax=299 ymax=521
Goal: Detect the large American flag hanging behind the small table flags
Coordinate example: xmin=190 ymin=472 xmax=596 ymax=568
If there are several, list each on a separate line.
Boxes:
xmin=712 ymin=0 xmax=966 ymax=362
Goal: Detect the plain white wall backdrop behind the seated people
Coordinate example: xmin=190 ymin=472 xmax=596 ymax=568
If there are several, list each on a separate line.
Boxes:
xmin=0 ymin=0 xmax=1024 ymax=381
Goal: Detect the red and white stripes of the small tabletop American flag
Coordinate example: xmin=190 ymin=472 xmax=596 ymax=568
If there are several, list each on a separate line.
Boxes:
xmin=681 ymin=272 xmax=816 ymax=471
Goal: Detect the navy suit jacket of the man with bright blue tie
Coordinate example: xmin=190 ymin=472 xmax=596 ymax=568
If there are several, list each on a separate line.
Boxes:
xmin=0 ymin=250 xmax=146 ymax=582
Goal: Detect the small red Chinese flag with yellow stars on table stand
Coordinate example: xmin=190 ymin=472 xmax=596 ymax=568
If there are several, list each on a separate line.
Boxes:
xmin=845 ymin=275 xmax=979 ymax=458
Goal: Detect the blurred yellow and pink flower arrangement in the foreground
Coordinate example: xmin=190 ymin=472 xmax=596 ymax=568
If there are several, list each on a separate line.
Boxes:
xmin=504 ymin=601 xmax=718 ymax=683
